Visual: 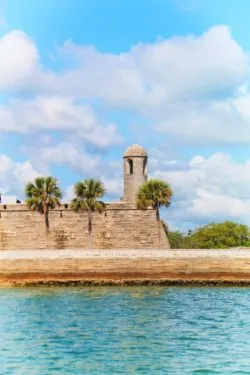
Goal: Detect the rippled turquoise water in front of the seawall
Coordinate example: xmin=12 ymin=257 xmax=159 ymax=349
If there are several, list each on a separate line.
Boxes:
xmin=0 ymin=287 xmax=250 ymax=375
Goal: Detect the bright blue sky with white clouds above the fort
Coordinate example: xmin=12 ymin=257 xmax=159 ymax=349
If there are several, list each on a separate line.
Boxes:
xmin=0 ymin=0 xmax=250 ymax=231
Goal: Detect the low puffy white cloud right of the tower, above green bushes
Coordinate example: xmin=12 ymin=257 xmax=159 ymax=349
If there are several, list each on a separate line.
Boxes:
xmin=154 ymin=153 xmax=250 ymax=229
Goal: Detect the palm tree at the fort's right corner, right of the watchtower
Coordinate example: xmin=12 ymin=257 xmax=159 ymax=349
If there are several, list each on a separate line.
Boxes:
xmin=137 ymin=179 xmax=173 ymax=247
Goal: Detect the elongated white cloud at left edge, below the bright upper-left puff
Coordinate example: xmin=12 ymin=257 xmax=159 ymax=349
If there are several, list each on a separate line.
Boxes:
xmin=0 ymin=96 xmax=122 ymax=148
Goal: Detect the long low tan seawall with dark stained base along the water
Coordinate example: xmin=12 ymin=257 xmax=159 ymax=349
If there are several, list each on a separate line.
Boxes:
xmin=0 ymin=249 xmax=250 ymax=286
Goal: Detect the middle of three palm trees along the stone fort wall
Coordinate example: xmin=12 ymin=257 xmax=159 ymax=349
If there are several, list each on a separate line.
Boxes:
xmin=72 ymin=179 xmax=105 ymax=249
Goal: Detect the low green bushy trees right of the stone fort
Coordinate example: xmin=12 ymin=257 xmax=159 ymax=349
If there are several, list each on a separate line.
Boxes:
xmin=163 ymin=221 xmax=250 ymax=249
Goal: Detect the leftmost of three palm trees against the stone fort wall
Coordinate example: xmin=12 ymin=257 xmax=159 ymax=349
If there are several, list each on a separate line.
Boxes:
xmin=25 ymin=176 xmax=62 ymax=232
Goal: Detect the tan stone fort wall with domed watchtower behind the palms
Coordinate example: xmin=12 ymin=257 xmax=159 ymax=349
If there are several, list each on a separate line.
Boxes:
xmin=0 ymin=145 xmax=169 ymax=250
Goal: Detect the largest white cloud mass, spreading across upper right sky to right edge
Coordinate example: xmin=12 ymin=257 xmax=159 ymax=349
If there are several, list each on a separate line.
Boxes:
xmin=47 ymin=26 xmax=250 ymax=144
